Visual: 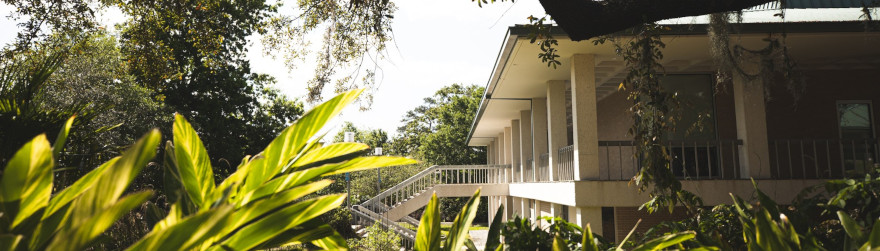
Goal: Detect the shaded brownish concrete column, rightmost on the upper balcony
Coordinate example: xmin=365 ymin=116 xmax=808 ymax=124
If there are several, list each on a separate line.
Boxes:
xmin=733 ymin=74 xmax=770 ymax=179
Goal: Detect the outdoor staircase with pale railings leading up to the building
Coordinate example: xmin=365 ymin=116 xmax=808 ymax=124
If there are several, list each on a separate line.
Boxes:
xmin=349 ymin=165 xmax=510 ymax=249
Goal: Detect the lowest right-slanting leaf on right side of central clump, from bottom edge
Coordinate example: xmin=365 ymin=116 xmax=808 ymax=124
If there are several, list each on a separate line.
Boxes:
xmin=212 ymin=194 xmax=345 ymax=250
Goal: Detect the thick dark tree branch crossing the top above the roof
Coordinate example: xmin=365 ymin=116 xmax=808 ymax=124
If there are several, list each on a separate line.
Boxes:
xmin=540 ymin=0 xmax=772 ymax=41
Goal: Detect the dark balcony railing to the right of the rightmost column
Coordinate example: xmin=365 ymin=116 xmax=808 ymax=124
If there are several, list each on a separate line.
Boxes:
xmin=769 ymin=139 xmax=880 ymax=179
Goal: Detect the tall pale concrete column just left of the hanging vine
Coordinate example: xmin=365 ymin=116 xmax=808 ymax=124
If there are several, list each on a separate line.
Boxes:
xmin=571 ymin=54 xmax=599 ymax=180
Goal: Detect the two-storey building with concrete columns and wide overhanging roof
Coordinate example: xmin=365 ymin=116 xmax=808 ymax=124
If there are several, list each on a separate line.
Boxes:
xmin=350 ymin=4 xmax=880 ymax=246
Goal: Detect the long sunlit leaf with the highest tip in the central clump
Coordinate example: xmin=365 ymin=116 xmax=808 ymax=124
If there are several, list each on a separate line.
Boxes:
xmin=244 ymin=89 xmax=363 ymax=191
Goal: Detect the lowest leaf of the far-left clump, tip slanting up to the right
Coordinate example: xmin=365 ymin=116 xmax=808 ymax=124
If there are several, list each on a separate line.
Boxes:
xmin=46 ymin=191 xmax=153 ymax=251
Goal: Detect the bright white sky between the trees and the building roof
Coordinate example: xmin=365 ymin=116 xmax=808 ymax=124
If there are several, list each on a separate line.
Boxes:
xmin=0 ymin=0 xmax=544 ymax=138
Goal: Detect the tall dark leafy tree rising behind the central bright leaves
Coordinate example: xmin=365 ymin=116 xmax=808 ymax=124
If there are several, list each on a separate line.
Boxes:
xmin=122 ymin=0 xmax=303 ymax=173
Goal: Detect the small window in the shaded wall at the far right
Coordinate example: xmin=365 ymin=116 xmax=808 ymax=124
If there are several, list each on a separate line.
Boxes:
xmin=837 ymin=101 xmax=877 ymax=171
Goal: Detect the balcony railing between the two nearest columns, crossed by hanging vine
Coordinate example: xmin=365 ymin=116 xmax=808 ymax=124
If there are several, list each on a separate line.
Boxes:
xmin=599 ymin=140 xmax=742 ymax=180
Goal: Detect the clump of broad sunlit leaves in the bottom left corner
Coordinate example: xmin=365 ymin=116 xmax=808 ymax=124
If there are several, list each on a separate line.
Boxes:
xmin=0 ymin=118 xmax=160 ymax=250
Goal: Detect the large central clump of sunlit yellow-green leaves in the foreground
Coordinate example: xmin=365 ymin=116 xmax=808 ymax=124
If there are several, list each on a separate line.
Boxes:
xmin=145 ymin=90 xmax=414 ymax=250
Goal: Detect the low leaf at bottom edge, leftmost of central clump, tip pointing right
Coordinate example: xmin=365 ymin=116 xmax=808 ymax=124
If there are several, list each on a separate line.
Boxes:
xmin=126 ymin=205 xmax=233 ymax=251
